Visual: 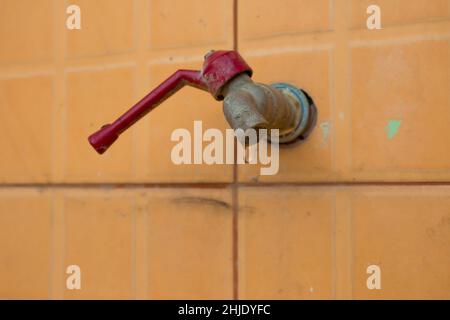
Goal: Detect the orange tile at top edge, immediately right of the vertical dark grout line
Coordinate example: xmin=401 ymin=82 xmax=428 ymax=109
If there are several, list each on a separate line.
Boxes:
xmin=238 ymin=0 xmax=332 ymax=40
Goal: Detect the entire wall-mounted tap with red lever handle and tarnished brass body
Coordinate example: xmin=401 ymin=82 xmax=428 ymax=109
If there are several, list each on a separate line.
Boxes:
xmin=88 ymin=51 xmax=317 ymax=154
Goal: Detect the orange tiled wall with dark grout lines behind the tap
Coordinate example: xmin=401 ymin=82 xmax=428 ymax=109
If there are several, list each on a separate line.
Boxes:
xmin=0 ymin=0 xmax=450 ymax=299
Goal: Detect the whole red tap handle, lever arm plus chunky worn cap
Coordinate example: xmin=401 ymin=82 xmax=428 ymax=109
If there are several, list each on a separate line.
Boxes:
xmin=88 ymin=51 xmax=252 ymax=154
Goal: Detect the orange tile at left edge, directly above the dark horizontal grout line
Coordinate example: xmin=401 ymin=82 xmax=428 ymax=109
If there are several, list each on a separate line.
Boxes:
xmin=0 ymin=75 xmax=53 ymax=183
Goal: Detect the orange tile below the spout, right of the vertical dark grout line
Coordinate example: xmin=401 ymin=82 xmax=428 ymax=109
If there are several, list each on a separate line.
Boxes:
xmin=238 ymin=187 xmax=334 ymax=299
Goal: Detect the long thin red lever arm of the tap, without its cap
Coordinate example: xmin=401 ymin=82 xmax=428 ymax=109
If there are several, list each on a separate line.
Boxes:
xmin=88 ymin=70 xmax=208 ymax=154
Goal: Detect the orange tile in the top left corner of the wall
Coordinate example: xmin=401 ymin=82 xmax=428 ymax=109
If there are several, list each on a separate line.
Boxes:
xmin=0 ymin=0 xmax=53 ymax=65
